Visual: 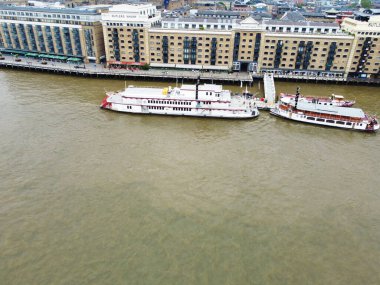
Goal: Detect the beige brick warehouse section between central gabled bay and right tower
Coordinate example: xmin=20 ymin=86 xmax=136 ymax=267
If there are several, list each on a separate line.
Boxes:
xmin=259 ymin=21 xmax=354 ymax=77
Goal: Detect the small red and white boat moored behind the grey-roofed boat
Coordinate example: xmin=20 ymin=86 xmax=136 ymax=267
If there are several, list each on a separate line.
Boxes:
xmin=280 ymin=93 xmax=355 ymax=107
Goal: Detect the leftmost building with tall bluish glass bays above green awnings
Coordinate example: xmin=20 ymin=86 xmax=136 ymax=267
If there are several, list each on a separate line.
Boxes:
xmin=0 ymin=6 xmax=105 ymax=63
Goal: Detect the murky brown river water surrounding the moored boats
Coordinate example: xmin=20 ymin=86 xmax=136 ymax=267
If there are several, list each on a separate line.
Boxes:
xmin=0 ymin=70 xmax=380 ymax=285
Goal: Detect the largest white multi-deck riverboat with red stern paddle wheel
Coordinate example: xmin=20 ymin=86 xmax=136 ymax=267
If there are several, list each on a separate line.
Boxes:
xmin=100 ymin=79 xmax=259 ymax=119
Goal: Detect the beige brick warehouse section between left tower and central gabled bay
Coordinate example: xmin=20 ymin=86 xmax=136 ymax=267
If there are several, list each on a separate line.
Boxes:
xmin=149 ymin=18 xmax=236 ymax=70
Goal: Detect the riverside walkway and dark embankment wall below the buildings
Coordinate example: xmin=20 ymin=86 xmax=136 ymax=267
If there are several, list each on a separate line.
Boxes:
xmin=0 ymin=58 xmax=380 ymax=86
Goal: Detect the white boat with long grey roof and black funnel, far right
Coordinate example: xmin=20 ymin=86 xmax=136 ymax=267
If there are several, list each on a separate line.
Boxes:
xmin=270 ymin=88 xmax=379 ymax=132
